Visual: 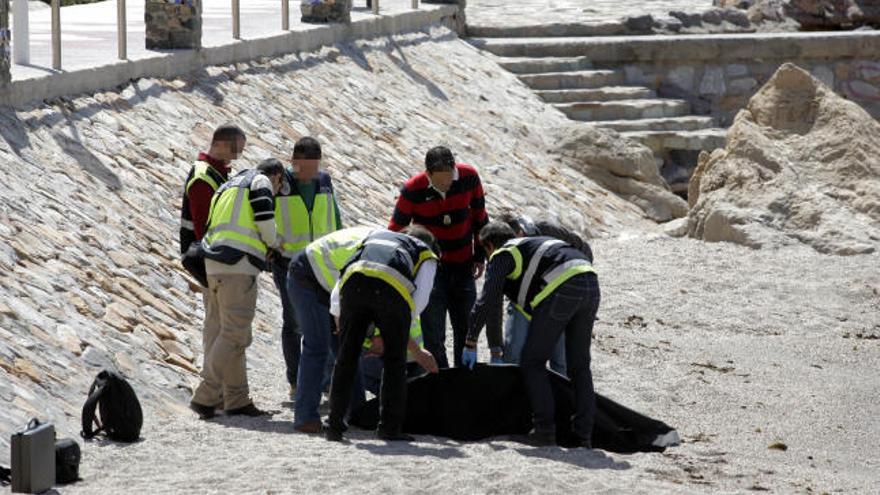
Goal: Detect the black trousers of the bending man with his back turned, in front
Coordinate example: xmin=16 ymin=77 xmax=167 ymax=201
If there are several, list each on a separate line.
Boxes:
xmin=329 ymin=274 xmax=411 ymax=434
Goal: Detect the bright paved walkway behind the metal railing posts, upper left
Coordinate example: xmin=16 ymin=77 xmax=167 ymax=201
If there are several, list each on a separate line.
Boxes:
xmin=11 ymin=0 xmax=433 ymax=80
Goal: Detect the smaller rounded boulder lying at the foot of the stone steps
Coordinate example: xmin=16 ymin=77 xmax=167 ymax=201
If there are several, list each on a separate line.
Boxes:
xmin=553 ymin=124 xmax=687 ymax=222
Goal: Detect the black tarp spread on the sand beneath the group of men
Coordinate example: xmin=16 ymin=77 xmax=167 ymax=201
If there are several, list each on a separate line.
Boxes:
xmin=351 ymin=364 xmax=679 ymax=453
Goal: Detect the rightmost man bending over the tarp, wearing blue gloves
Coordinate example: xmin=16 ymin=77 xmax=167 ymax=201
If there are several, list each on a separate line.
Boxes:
xmin=462 ymin=221 xmax=599 ymax=447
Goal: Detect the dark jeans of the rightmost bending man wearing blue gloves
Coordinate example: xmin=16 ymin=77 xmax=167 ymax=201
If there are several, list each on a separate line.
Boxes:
xmin=520 ymin=273 xmax=599 ymax=446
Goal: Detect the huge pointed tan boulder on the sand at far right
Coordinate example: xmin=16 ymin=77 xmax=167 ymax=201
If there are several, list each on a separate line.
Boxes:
xmin=688 ymin=64 xmax=880 ymax=255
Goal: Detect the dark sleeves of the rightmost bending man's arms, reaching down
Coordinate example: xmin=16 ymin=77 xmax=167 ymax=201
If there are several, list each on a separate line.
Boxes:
xmin=466 ymin=252 xmax=516 ymax=347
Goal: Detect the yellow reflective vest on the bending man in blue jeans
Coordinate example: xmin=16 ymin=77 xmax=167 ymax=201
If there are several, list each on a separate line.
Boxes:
xmin=306 ymin=227 xmax=373 ymax=292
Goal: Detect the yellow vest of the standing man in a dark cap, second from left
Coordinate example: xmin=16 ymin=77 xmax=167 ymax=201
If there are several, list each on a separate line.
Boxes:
xmin=275 ymin=193 xmax=339 ymax=258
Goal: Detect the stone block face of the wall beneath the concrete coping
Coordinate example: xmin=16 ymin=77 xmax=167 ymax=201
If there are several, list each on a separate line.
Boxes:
xmin=624 ymin=58 xmax=880 ymax=127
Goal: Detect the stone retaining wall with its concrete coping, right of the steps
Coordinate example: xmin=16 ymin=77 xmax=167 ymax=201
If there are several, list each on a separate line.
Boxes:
xmin=596 ymin=33 xmax=880 ymax=126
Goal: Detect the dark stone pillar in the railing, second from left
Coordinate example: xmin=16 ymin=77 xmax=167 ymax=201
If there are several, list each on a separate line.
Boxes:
xmin=144 ymin=0 xmax=202 ymax=50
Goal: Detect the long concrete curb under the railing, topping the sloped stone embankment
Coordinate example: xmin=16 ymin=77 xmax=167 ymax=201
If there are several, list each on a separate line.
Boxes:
xmin=0 ymin=5 xmax=458 ymax=106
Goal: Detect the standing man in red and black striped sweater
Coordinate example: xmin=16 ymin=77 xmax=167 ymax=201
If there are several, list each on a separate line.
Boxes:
xmin=388 ymin=146 xmax=492 ymax=368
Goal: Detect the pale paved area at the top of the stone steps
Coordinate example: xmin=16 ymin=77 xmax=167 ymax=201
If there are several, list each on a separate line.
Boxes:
xmin=467 ymin=0 xmax=712 ymax=27
